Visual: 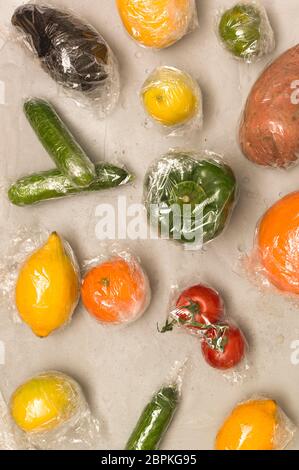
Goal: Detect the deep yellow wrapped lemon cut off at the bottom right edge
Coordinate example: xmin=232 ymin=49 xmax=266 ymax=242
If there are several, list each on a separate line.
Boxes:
xmin=215 ymin=399 xmax=278 ymax=450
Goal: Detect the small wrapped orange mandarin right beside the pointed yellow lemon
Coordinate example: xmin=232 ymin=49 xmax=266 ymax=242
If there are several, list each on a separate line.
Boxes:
xmin=81 ymin=250 xmax=151 ymax=325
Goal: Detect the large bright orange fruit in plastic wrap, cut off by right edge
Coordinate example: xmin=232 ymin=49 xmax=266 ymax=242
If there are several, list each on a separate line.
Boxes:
xmin=244 ymin=191 xmax=299 ymax=295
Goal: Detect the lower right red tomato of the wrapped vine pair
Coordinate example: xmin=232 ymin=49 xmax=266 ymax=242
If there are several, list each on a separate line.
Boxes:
xmin=201 ymin=324 xmax=246 ymax=370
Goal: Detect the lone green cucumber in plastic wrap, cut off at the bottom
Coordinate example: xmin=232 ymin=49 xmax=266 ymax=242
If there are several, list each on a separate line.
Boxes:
xmin=125 ymin=385 xmax=179 ymax=450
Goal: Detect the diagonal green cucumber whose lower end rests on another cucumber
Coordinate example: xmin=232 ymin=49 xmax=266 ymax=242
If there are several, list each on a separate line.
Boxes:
xmin=24 ymin=98 xmax=96 ymax=187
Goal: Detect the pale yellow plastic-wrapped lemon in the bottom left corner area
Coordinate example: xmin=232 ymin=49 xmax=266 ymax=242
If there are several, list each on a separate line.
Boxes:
xmin=10 ymin=372 xmax=82 ymax=433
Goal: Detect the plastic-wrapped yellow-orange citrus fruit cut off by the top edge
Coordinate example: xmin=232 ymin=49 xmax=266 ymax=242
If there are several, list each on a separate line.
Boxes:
xmin=116 ymin=0 xmax=198 ymax=49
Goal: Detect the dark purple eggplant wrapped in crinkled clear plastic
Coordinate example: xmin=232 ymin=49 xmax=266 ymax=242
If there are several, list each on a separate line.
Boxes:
xmin=12 ymin=3 xmax=120 ymax=117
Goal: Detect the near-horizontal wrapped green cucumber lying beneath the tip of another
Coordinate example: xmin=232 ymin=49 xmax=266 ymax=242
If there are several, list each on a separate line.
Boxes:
xmin=8 ymin=163 xmax=133 ymax=206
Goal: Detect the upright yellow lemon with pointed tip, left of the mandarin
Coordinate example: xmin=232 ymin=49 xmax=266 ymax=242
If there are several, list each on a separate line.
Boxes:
xmin=16 ymin=232 xmax=79 ymax=337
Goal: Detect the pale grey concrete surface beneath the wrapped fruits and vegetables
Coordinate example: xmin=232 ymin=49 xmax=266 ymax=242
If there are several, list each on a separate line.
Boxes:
xmin=0 ymin=0 xmax=299 ymax=449
